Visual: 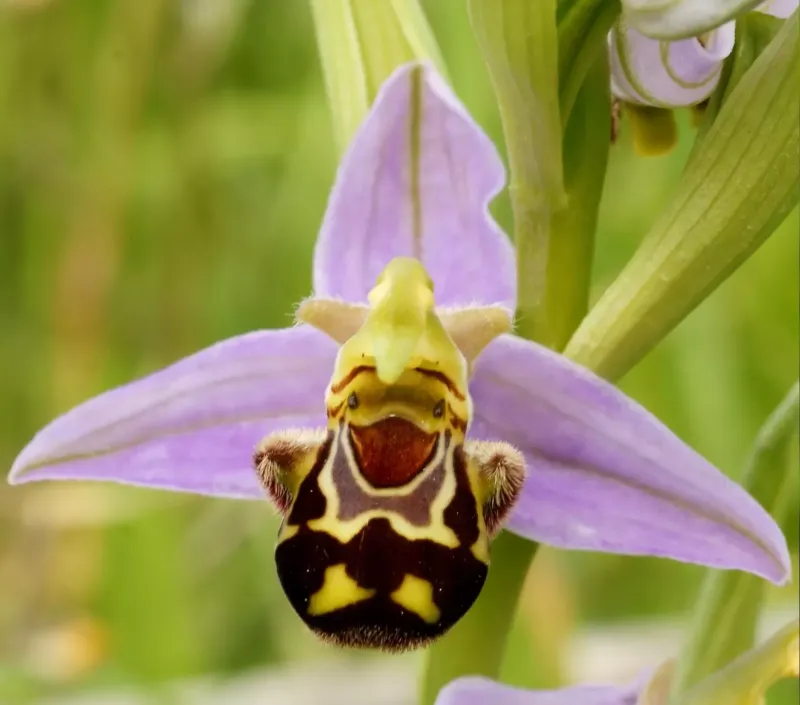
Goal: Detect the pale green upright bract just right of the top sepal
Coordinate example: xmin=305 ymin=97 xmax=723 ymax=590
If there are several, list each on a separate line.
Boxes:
xmin=469 ymin=0 xmax=566 ymax=344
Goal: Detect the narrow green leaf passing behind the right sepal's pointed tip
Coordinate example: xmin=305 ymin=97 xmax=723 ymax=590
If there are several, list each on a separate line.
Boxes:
xmin=672 ymin=384 xmax=800 ymax=698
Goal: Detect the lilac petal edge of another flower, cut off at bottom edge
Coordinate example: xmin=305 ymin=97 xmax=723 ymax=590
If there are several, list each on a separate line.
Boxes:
xmin=435 ymin=677 xmax=638 ymax=705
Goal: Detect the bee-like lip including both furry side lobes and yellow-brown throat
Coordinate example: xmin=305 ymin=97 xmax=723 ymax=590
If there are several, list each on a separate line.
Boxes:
xmin=255 ymin=356 xmax=524 ymax=651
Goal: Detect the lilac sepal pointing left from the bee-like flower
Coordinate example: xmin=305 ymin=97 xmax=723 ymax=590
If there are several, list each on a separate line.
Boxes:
xmin=9 ymin=326 xmax=336 ymax=498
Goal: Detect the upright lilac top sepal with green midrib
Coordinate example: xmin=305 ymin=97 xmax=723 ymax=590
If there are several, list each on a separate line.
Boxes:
xmin=314 ymin=64 xmax=516 ymax=308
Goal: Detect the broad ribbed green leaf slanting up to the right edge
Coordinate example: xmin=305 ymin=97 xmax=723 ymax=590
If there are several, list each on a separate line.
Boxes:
xmin=566 ymin=13 xmax=800 ymax=379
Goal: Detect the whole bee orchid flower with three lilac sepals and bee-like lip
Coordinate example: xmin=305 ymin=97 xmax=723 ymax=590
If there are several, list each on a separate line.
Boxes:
xmin=10 ymin=64 xmax=789 ymax=650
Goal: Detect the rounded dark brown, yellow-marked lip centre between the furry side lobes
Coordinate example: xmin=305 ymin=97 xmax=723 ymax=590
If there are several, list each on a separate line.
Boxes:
xmin=276 ymin=421 xmax=488 ymax=650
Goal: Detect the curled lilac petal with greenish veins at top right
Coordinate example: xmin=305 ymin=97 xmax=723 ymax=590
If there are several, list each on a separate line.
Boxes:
xmin=609 ymin=20 xmax=736 ymax=108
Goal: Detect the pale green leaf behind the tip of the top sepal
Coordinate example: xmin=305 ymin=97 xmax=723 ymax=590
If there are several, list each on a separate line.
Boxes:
xmin=310 ymin=0 xmax=446 ymax=153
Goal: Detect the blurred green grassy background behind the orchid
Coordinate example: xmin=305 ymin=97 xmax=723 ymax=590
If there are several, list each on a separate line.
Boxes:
xmin=0 ymin=0 xmax=799 ymax=705
